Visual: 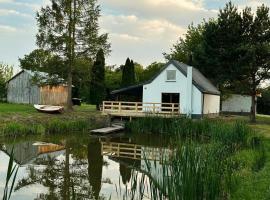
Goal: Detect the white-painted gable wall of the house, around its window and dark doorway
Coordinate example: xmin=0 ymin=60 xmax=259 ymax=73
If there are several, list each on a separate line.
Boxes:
xmin=143 ymin=64 xmax=202 ymax=115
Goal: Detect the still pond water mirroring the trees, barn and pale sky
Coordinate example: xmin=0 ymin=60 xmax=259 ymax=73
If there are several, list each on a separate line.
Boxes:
xmin=0 ymin=133 xmax=171 ymax=200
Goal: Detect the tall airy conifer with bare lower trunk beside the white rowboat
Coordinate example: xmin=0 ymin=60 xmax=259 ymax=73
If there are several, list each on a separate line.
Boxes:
xmin=37 ymin=0 xmax=110 ymax=110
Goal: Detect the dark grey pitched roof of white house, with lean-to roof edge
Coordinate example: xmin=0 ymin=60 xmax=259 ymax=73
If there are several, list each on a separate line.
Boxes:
xmin=111 ymin=60 xmax=220 ymax=95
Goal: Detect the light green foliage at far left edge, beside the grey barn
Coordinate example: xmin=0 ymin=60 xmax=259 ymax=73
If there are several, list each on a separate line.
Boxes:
xmin=0 ymin=63 xmax=13 ymax=101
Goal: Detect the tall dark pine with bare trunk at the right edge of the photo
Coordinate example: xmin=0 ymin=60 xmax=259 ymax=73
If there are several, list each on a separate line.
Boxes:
xmin=241 ymin=5 xmax=270 ymax=122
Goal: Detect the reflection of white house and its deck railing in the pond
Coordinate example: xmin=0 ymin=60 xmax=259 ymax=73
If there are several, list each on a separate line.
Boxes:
xmin=101 ymin=138 xmax=174 ymax=184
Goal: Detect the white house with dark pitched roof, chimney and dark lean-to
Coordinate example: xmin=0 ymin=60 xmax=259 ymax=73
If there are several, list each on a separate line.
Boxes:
xmin=108 ymin=60 xmax=220 ymax=118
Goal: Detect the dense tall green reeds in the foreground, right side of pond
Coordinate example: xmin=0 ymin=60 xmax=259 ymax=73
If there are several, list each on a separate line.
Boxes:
xmin=123 ymin=143 xmax=232 ymax=200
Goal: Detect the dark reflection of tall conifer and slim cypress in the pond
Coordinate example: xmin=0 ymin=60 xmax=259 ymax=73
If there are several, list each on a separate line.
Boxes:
xmin=15 ymin=141 xmax=103 ymax=200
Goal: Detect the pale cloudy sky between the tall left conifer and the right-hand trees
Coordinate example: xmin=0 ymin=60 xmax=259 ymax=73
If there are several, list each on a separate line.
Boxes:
xmin=99 ymin=0 xmax=217 ymax=65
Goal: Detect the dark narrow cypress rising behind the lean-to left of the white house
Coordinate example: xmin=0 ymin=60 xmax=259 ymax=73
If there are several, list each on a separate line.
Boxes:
xmin=121 ymin=58 xmax=135 ymax=87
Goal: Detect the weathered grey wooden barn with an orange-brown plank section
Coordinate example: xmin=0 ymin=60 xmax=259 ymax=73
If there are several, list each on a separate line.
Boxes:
xmin=7 ymin=70 xmax=67 ymax=105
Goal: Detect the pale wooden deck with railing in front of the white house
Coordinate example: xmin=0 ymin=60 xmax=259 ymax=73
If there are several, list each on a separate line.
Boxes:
xmin=102 ymin=101 xmax=180 ymax=117
